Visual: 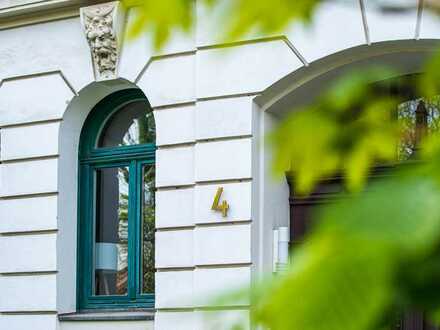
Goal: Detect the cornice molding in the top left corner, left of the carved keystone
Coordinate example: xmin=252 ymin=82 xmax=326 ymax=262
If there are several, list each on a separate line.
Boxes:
xmin=0 ymin=0 xmax=108 ymax=30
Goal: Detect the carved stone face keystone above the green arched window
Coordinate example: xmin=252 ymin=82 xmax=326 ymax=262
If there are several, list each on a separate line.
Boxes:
xmin=80 ymin=1 xmax=123 ymax=80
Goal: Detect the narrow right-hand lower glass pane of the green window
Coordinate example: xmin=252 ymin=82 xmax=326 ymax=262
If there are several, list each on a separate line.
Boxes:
xmin=141 ymin=166 xmax=155 ymax=293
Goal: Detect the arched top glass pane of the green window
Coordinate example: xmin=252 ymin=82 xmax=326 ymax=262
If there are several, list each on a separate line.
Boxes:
xmin=98 ymin=101 xmax=155 ymax=147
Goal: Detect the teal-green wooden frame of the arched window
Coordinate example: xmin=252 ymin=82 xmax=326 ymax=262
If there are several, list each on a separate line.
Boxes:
xmin=77 ymin=89 xmax=156 ymax=310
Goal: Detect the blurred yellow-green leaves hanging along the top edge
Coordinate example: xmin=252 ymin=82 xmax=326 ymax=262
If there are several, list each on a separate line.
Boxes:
xmin=123 ymin=0 xmax=321 ymax=48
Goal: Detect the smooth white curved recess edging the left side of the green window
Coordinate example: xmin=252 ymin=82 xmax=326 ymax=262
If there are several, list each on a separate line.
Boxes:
xmin=57 ymin=79 xmax=137 ymax=313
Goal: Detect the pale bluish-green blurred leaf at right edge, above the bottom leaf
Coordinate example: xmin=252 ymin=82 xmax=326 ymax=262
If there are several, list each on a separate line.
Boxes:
xmin=319 ymin=174 xmax=440 ymax=255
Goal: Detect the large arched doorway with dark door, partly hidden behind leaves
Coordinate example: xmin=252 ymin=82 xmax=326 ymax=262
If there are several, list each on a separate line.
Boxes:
xmin=255 ymin=41 xmax=436 ymax=330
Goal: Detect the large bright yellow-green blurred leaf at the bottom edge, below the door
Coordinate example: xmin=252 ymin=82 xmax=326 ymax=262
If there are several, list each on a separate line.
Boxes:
xmin=253 ymin=236 xmax=391 ymax=330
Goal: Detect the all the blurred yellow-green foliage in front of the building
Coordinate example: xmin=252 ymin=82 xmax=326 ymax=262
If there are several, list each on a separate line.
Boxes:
xmin=120 ymin=0 xmax=440 ymax=330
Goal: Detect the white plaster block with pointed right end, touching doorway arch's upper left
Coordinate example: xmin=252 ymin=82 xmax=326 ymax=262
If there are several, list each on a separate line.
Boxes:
xmin=196 ymin=40 xmax=302 ymax=98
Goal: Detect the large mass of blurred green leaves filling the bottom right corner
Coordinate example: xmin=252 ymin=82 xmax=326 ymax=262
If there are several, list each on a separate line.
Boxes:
xmin=253 ymin=176 xmax=440 ymax=330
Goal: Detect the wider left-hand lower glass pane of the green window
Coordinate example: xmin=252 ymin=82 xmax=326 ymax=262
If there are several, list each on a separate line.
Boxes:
xmin=94 ymin=167 xmax=129 ymax=295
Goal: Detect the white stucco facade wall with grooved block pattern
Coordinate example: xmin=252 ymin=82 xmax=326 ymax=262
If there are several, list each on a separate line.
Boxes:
xmin=0 ymin=1 xmax=440 ymax=330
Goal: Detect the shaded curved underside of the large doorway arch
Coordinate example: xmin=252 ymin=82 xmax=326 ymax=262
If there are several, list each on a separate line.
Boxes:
xmin=254 ymin=39 xmax=440 ymax=116
